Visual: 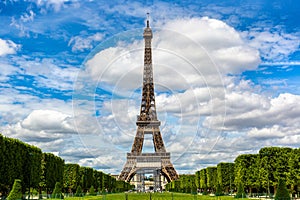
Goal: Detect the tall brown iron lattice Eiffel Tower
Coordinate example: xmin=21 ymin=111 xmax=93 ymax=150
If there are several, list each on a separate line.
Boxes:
xmin=118 ymin=17 xmax=178 ymax=182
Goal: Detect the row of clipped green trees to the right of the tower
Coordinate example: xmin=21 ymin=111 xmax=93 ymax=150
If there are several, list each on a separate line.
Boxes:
xmin=166 ymin=147 xmax=300 ymax=194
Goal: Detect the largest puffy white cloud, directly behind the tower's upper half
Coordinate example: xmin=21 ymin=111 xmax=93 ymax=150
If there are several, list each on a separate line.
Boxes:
xmin=86 ymin=18 xmax=260 ymax=93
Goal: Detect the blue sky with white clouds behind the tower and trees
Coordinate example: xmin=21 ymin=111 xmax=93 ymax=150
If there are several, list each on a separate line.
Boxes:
xmin=0 ymin=0 xmax=300 ymax=173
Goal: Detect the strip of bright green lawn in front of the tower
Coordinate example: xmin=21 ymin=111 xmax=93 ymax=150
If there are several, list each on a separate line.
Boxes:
xmin=65 ymin=192 xmax=241 ymax=200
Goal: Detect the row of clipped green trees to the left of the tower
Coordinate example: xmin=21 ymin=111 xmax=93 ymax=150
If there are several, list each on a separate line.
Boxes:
xmin=0 ymin=134 xmax=132 ymax=196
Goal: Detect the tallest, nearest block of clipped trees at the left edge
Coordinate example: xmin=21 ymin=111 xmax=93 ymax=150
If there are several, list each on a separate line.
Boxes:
xmin=0 ymin=134 xmax=42 ymax=193
